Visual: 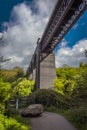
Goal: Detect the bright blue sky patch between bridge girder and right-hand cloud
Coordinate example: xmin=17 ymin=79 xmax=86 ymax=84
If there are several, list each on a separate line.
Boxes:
xmin=55 ymin=11 xmax=87 ymax=51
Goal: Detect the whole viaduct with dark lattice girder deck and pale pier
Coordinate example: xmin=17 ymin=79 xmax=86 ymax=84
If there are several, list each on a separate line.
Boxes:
xmin=26 ymin=0 xmax=87 ymax=89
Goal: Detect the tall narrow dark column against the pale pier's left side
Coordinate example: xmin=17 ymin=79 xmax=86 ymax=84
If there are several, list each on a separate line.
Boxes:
xmin=35 ymin=38 xmax=40 ymax=89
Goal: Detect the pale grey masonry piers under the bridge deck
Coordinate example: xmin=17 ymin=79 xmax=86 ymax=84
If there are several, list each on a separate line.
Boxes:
xmin=29 ymin=53 xmax=56 ymax=89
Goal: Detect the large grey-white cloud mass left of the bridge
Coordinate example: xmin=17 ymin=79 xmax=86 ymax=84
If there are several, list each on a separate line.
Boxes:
xmin=0 ymin=0 xmax=57 ymax=68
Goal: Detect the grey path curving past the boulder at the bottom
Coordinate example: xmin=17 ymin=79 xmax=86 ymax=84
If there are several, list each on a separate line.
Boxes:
xmin=31 ymin=112 xmax=77 ymax=130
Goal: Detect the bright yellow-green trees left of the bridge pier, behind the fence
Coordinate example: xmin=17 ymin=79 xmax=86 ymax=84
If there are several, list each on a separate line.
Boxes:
xmin=0 ymin=67 xmax=34 ymax=114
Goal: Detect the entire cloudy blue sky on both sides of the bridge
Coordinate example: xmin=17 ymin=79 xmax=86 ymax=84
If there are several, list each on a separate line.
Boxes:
xmin=0 ymin=0 xmax=87 ymax=70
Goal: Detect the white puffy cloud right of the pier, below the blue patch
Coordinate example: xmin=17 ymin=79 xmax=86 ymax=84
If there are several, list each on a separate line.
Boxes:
xmin=55 ymin=39 xmax=87 ymax=67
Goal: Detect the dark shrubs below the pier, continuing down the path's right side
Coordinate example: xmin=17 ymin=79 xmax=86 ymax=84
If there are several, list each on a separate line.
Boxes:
xmin=28 ymin=89 xmax=87 ymax=130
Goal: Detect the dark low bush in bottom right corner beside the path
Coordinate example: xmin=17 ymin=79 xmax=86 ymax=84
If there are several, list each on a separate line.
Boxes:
xmin=65 ymin=107 xmax=87 ymax=130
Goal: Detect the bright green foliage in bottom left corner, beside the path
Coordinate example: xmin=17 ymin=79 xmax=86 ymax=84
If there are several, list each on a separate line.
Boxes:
xmin=0 ymin=114 xmax=29 ymax=130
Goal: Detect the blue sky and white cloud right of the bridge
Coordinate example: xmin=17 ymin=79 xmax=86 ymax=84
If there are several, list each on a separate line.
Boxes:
xmin=55 ymin=11 xmax=87 ymax=67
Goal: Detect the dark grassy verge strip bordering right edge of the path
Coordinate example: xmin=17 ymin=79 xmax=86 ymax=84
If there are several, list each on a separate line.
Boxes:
xmin=45 ymin=106 xmax=87 ymax=130
